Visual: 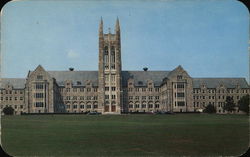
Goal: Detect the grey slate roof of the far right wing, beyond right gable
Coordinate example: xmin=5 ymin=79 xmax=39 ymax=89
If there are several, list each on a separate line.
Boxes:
xmin=193 ymin=78 xmax=249 ymax=88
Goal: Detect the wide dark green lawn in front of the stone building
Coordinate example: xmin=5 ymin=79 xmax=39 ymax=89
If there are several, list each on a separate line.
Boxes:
xmin=2 ymin=114 xmax=249 ymax=156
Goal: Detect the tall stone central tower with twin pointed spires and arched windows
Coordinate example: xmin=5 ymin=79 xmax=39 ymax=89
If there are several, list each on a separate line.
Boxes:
xmin=98 ymin=18 xmax=122 ymax=114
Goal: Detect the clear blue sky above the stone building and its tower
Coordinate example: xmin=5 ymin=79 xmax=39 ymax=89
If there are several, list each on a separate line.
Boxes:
xmin=1 ymin=0 xmax=249 ymax=79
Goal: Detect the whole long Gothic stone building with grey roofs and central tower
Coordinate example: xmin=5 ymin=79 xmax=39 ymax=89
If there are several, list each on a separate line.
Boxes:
xmin=0 ymin=19 xmax=250 ymax=114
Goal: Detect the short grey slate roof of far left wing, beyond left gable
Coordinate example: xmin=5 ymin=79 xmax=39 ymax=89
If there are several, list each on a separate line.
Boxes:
xmin=0 ymin=78 xmax=26 ymax=89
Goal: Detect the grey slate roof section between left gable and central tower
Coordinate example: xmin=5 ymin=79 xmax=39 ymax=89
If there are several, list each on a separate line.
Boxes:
xmin=48 ymin=71 xmax=98 ymax=86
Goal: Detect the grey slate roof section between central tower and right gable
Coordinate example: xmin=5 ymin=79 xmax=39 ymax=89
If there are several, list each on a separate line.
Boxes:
xmin=122 ymin=71 xmax=170 ymax=86
